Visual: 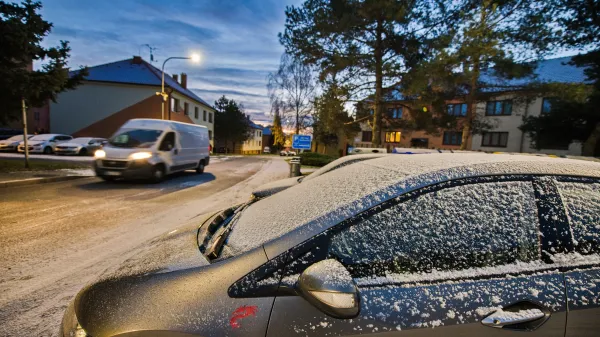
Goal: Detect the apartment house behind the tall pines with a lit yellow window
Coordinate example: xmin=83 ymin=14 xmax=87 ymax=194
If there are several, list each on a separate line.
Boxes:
xmin=354 ymin=57 xmax=586 ymax=155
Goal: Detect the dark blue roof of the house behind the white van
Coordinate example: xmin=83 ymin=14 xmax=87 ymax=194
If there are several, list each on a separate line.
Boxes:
xmin=71 ymin=58 xmax=211 ymax=107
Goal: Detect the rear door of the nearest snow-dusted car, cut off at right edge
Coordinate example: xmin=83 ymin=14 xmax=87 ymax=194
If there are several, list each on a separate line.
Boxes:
xmin=556 ymin=178 xmax=600 ymax=337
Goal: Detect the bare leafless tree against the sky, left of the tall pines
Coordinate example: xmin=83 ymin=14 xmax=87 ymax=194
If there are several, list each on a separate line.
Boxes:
xmin=267 ymin=54 xmax=316 ymax=134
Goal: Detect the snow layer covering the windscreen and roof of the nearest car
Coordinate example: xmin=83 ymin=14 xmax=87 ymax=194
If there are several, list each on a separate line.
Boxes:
xmin=228 ymin=153 xmax=600 ymax=258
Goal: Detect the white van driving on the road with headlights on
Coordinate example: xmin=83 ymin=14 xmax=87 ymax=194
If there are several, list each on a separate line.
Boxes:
xmin=94 ymin=119 xmax=210 ymax=181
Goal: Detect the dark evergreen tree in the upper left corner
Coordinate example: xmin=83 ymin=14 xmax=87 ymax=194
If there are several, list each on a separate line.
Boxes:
xmin=0 ymin=0 xmax=87 ymax=123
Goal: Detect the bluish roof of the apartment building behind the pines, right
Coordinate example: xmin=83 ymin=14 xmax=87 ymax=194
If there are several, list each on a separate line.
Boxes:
xmin=386 ymin=56 xmax=588 ymax=101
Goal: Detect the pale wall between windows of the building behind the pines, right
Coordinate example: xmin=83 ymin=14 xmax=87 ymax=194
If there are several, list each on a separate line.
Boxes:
xmin=471 ymin=94 xmax=581 ymax=155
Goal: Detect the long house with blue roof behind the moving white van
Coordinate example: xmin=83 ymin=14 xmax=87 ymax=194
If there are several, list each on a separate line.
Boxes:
xmin=50 ymin=56 xmax=215 ymax=145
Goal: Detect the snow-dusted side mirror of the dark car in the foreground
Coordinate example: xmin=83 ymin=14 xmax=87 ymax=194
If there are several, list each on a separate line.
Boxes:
xmin=298 ymin=259 xmax=360 ymax=318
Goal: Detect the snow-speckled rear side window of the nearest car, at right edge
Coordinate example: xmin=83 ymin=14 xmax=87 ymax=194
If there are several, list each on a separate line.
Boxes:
xmin=557 ymin=182 xmax=600 ymax=254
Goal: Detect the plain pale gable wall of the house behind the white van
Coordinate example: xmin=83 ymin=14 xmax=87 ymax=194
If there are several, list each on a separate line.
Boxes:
xmin=50 ymin=82 xmax=160 ymax=134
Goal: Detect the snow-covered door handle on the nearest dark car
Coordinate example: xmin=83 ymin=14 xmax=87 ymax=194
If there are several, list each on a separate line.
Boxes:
xmin=481 ymin=302 xmax=550 ymax=331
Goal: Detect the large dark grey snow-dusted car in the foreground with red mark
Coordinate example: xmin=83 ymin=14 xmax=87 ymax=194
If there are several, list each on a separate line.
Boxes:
xmin=60 ymin=153 xmax=600 ymax=337
